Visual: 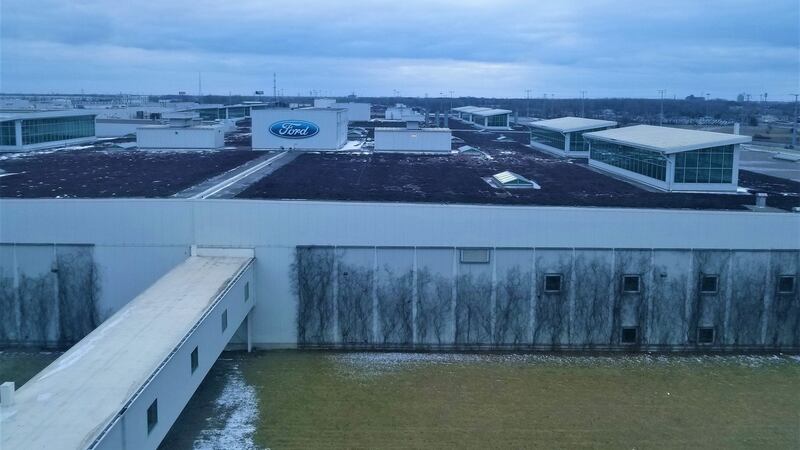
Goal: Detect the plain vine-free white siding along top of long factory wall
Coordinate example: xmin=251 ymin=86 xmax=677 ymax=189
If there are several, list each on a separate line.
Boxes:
xmin=0 ymin=199 xmax=800 ymax=346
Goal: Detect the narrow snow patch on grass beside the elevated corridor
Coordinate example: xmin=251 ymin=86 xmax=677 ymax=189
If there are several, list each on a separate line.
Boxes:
xmin=193 ymin=365 xmax=258 ymax=450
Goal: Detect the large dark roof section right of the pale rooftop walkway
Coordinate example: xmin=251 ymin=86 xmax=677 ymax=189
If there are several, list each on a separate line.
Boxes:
xmin=237 ymin=126 xmax=800 ymax=210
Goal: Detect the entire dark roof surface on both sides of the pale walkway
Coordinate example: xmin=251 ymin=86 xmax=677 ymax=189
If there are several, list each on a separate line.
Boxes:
xmin=0 ymin=126 xmax=800 ymax=210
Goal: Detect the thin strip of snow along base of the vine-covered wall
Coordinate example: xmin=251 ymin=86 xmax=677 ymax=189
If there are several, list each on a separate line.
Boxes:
xmin=327 ymin=352 xmax=800 ymax=378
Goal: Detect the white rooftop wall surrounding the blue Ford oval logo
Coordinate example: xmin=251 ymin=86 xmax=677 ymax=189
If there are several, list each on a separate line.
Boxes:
xmin=252 ymin=108 xmax=347 ymax=150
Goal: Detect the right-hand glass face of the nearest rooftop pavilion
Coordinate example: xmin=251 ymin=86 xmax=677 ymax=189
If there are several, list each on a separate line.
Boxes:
xmin=674 ymin=145 xmax=733 ymax=183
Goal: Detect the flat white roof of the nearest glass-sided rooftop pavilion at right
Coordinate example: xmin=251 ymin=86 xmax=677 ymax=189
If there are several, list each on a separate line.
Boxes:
xmin=583 ymin=125 xmax=753 ymax=153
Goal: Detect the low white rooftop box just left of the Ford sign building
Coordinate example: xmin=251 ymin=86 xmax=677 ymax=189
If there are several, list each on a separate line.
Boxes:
xmin=136 ymin=126 xmax=225 ymax=149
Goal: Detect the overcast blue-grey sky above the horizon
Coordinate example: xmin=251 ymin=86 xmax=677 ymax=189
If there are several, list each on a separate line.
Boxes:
xmin=0 ymin=0 xmax=800 ymax=100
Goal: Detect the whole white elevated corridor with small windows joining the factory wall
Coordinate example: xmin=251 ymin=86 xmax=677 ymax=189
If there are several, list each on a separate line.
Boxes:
xmin=0 ymin=249 xmax=255 ymax=450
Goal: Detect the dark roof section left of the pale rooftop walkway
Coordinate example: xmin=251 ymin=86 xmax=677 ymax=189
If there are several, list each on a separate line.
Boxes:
xmin=0 ymin=146 xmax=263 ymax=198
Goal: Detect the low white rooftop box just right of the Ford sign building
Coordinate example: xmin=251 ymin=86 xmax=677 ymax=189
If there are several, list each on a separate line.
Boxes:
xmin=375 ymin=122 xmax=453 ymax=153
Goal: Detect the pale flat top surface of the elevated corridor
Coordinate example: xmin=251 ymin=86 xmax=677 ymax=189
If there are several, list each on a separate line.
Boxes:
xmin=0 ymin=256 xmax=252 ymax=450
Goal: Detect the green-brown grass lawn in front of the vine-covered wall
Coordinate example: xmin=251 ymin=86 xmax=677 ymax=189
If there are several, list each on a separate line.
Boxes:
xmin=244 ymin=351 xmax=800 ymax=449
